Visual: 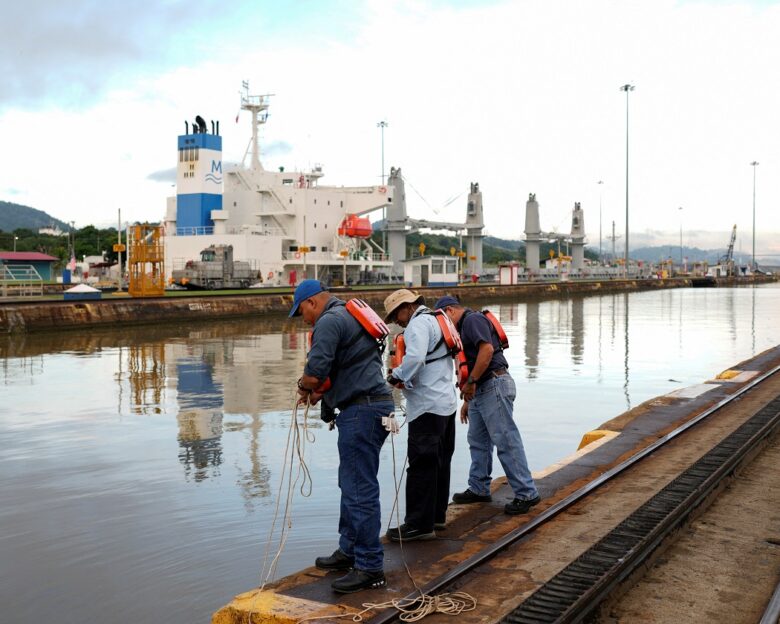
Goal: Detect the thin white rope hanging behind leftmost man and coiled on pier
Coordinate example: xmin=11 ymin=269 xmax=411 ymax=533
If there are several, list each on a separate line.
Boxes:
xmin=296 ymin=412 xmax=477 ymax=624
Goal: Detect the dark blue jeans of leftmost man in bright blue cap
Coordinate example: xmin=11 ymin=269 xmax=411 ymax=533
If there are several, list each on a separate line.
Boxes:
xmin=336 ymin=401 xmax=393 ymax=572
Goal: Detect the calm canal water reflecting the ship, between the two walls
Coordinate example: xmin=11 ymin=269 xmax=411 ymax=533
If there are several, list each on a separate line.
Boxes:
xmin=0 ymin=284 xmax=780 ymax=624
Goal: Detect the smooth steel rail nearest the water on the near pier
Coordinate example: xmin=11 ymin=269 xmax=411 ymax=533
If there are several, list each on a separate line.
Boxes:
xmin=369 ymin=366 xmax=780 ymax=624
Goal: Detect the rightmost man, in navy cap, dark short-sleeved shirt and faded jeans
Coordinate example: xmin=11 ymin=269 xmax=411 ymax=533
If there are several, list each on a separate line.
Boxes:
xmin=436 ymin=295 xmax=540 ymax=515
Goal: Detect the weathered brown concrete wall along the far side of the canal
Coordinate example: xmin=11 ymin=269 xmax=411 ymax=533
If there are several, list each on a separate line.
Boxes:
xmin=0 ymin=275 xmax=776 ymax=334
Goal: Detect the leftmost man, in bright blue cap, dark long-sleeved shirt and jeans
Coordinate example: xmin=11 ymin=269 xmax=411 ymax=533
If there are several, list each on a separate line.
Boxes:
xmin=290 ymin=279 xmax=393 ymax=593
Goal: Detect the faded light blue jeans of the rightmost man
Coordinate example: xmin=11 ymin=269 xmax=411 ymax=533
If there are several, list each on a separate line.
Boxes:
xmin=468 ymin=374 xmax=539 ymax=500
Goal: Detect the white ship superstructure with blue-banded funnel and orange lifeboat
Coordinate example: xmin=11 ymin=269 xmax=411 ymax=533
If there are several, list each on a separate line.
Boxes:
xmin=164 ymin=95 xmax=393 ymax=285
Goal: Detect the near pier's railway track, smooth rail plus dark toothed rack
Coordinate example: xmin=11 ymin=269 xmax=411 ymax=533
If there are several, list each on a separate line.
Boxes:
xmin=370 ymin=366 xmax=780 ymax=624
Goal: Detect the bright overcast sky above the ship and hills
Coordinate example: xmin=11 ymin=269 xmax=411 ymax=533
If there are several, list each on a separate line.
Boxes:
xmin=0 ymin=0 xmax=780 ymax=257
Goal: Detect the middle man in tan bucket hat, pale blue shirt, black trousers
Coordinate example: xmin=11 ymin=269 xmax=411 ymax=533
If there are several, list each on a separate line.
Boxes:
xmin=385 ymin=289 xmax=458 ymax=542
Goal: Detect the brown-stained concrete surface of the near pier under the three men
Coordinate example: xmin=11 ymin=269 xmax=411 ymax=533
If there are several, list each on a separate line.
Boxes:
xmin=212 ymin=345 xmax=780 ymax=624
